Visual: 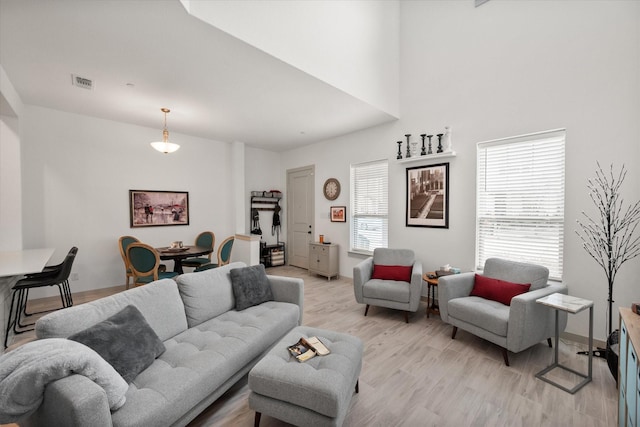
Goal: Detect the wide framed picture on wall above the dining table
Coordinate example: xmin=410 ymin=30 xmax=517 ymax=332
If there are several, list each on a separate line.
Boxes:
xmin=129 ymin=190 xmax=189 ymax=228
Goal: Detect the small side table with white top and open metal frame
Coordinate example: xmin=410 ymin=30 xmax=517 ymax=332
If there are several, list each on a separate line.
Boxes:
xmin=536 ymin=293 xmax=593 ymax=394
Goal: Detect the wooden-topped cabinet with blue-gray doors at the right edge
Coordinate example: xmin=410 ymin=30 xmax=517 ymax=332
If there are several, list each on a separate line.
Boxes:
xmin=618 ymin=308 xmax=640 ymax=427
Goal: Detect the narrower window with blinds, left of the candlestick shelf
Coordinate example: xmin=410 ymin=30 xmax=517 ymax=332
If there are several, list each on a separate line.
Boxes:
xmin=351 ymin=160 xmax=389 ymax=253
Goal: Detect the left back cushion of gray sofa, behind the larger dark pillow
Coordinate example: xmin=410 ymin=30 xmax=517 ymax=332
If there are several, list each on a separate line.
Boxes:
xmin=36 ymin=279 xmax=187 ymax=341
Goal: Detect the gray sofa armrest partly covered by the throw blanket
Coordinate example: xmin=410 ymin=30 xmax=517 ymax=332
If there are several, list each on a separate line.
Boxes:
xmin=20 ymin=375 xmax=112 ymax=427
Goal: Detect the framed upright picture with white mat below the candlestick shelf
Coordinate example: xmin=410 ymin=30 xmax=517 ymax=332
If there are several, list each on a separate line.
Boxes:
xmin=407 ymin=163 xmax=449 ymax=228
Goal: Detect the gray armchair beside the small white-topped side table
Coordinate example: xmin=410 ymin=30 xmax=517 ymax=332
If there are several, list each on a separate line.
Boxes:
xmin=438 ymin=258 xmax=567 ymax=366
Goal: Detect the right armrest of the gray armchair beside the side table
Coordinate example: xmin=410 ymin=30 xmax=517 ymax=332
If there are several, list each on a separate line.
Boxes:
xmin=507 ymin=284 xmax=568 ymax=352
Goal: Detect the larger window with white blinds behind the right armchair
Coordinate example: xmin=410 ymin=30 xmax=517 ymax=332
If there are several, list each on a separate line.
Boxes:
xmin=476 ymin=129 xmax=565 ymax=280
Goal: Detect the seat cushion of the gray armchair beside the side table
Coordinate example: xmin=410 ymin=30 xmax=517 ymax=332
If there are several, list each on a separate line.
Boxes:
xmin=448 ymin=297 xmax=509 ymax=337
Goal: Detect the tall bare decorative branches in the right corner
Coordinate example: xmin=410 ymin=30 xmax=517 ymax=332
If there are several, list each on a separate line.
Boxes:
xmin=576 ymin=163 xmax=640 ymax=334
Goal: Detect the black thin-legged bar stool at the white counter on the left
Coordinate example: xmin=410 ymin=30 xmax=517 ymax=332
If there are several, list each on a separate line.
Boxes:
xmin=4 ymin=246 xmax=78 ymax=348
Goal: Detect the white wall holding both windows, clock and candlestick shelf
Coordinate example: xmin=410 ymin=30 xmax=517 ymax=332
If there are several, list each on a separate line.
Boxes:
xmin=282 ymin=1 xmax=640 ymax=339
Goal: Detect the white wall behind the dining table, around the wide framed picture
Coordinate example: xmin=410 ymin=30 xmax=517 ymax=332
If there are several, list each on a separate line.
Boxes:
xmin=22 ymin=106 xmax=235 ymax=296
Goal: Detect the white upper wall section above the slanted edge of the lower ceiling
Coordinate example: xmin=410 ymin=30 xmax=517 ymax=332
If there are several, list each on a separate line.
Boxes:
xmin=182 ymin=0 xmax=400 ymax=116
